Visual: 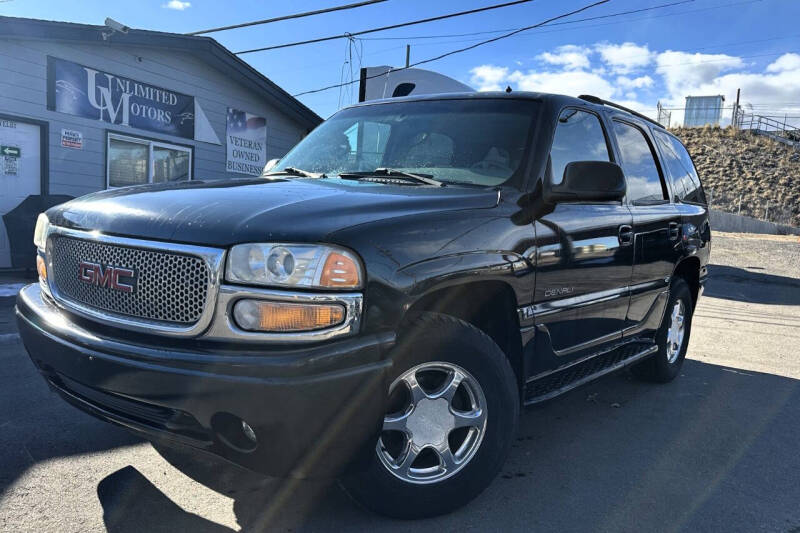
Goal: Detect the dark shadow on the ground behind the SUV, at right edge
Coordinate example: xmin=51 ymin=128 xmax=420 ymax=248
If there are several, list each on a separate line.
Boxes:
xmin=705 ymin=265 xmax=800 ymax=305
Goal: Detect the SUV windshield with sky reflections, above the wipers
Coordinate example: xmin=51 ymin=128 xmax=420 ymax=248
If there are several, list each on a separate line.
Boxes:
xmin=270 ymin=99 xmax=537 ymax=186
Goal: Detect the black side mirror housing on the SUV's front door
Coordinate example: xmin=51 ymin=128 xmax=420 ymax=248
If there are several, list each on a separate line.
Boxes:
xmin=544 ymin=161 xmax=627 ymax=204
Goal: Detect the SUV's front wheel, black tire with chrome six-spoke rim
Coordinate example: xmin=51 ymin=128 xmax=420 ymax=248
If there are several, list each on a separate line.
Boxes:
xmin=341 ymin=313 xmax=519 ymax=519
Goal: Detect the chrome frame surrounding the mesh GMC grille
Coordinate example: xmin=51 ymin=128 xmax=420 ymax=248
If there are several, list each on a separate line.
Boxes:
xmin=47 ymin=225 xmax=225 ymax=337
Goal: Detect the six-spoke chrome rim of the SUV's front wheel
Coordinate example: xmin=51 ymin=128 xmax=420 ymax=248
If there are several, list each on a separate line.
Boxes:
xmin=376 ymin=362 xmax=486 ymax=484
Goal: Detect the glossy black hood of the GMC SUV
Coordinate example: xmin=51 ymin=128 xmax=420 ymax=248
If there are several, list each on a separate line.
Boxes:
xmin=47 ymin=178 xmax=498 ymax=247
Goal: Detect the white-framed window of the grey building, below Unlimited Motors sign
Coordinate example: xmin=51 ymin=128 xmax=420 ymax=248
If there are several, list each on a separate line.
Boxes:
xmin=106 ymin=133 xmax=192 ymax=187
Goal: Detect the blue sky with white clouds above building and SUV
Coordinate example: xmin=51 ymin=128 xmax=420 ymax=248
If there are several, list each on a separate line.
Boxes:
xmin=0 ymin=0 xmax=800 ymax=123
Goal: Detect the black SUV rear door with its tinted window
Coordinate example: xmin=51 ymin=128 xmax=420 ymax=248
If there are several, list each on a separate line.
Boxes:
xmin=612 ymin=115 xmax=680 ymax=338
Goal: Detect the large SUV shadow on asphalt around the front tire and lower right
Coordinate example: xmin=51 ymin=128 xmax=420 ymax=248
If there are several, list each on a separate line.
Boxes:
xmin=145 ymin=360 xmax=800 ymax=532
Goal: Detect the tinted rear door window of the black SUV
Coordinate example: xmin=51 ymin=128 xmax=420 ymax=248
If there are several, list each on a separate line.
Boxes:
xmin=614 ymin=121 xmax=667 ymax=202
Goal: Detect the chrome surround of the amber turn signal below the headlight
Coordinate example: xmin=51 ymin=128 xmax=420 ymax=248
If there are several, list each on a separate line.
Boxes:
xmin=202 ymin=285 xmax=364 ymax=342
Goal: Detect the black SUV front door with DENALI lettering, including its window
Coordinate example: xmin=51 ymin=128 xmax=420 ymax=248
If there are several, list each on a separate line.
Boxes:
xmin=534 ymin=108 xmax=633 ymax=369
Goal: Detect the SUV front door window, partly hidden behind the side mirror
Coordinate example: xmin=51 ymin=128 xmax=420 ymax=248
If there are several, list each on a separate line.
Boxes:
xmin=550 ymin=109 xmax=611 ymax=183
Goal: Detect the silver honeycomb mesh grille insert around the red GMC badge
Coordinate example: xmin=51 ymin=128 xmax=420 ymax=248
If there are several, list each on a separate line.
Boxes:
xmin=48 ymin=235 xmax=210 ymax=325
